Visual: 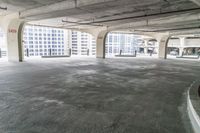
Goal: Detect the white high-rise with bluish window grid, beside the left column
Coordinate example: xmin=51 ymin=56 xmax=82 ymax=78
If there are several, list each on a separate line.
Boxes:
xmin=23 ymin=25 xmax=69 ymax=56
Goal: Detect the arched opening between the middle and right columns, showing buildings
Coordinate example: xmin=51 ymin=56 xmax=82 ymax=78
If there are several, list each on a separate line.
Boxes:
xmin=106 ymin=32 xmax=158 ymax=57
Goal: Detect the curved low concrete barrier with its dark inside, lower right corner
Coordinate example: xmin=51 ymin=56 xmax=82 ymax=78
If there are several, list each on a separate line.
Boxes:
xmin=187 ymin=81 xmax=200 ymax=133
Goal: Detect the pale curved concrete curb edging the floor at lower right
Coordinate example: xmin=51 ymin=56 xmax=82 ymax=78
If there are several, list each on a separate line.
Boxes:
xmin=187 ymin=81 xmax=200 ymax=133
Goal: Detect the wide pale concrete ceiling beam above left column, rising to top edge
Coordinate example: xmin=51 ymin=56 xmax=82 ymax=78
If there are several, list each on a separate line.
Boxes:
xmin=20 ymin=0 xmax=115 ymax=18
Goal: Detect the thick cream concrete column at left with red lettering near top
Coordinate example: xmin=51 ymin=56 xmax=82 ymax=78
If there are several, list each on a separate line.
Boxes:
xmin=7 ymin=19 xmax=24 ymax=62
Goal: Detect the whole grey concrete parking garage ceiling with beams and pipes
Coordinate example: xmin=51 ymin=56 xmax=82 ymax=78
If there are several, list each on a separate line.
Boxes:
xmin=0 ymin=0 xmax=200 ymax=33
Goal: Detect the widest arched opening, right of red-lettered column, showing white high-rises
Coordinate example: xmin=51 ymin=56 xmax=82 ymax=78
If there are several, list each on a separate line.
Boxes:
xmin=23 ymin=25 xmax=96 ymax=56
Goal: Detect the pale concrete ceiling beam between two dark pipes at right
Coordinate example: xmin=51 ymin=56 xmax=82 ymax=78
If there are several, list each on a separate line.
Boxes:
xmin=109 ymin=10 xmax=200 ymax=30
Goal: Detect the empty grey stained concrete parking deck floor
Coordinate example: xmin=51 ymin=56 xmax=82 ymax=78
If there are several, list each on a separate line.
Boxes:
xmin=0 ymin=58 xmax=200 ymax=133
